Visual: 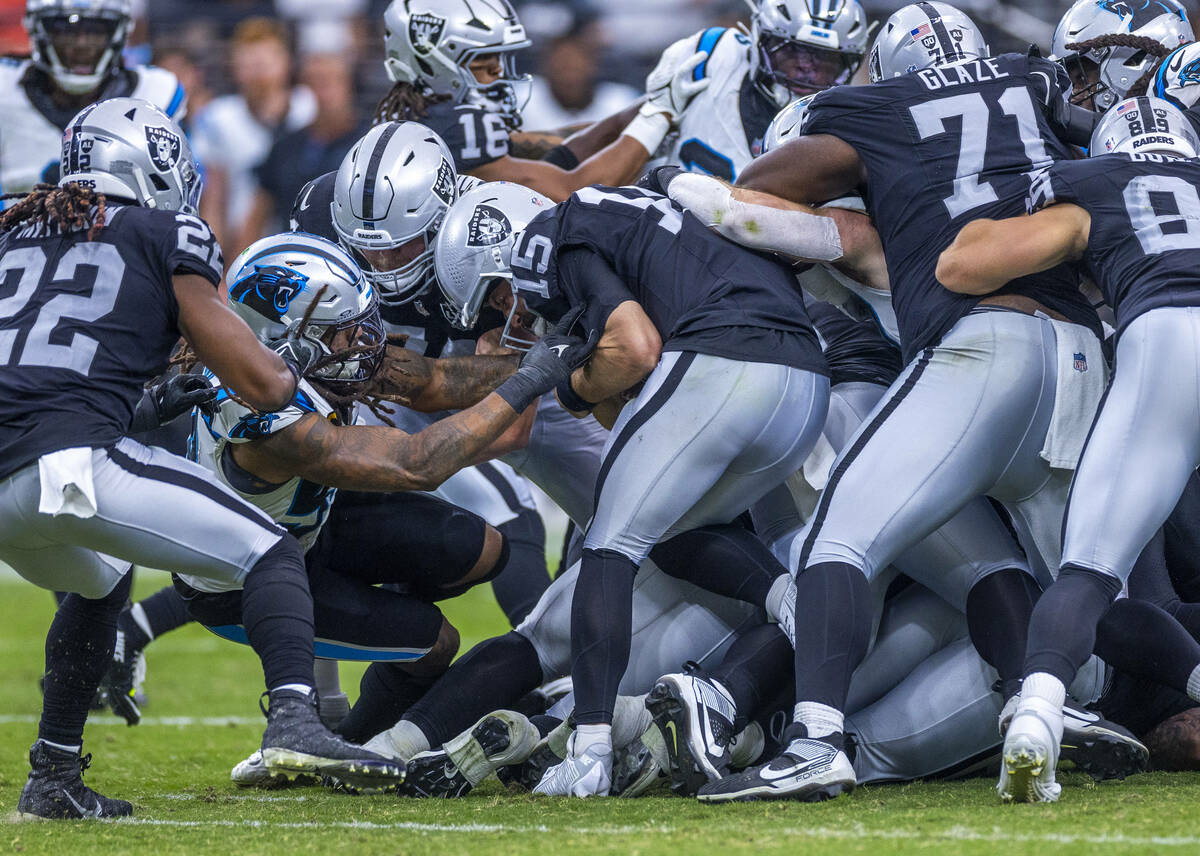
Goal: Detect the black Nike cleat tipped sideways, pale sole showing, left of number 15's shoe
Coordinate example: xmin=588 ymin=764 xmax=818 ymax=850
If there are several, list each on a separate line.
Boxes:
xmin=398 ymin=711 xmax=539 ymax=797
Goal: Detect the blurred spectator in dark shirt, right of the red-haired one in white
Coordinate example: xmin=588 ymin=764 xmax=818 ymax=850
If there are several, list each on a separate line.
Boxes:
xmin=239 ymin=54 xmax=371 ymax=247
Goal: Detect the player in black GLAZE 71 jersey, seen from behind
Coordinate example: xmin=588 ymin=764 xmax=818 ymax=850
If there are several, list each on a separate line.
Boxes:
xmin=702 ymin=2 xmax=1103 ymax=800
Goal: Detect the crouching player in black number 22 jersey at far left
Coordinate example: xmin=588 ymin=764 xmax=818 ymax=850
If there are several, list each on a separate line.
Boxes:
xmin=0 ymin=98 xmax=402 ymax=818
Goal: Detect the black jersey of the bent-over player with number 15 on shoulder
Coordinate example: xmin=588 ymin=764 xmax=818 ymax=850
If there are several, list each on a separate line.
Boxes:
xmin=512 ymin=186 xmax=828 ymax=373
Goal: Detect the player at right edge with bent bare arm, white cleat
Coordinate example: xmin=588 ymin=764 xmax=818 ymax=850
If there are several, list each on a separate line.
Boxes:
xmin=937 ymin=96 xmax=1200 ymax=802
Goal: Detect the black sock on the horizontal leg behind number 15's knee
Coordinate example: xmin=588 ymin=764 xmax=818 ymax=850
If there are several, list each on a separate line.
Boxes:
xmin=650 ymin=523 xmax=787 ymax=611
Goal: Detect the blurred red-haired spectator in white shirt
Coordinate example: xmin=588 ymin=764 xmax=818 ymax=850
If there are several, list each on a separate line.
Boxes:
xmin=192 ymin=18 xmax=317 ymax=258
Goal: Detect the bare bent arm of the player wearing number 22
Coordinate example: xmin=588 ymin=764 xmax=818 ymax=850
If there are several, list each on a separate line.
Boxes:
xmin=173 ymin=274 xmax=296 ymax=412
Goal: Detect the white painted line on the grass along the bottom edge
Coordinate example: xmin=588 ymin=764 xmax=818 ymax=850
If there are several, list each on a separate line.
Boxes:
xmin=104 ymin=818 xmax=1200 ymax=848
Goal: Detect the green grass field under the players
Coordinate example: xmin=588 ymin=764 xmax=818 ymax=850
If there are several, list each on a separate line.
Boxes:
xmin=0 ymin=574 xmax=1200 ymax=856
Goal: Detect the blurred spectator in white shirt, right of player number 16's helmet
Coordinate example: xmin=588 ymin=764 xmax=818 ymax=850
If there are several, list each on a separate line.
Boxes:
xmin=521 ymin=28 xmax=642 ymax=131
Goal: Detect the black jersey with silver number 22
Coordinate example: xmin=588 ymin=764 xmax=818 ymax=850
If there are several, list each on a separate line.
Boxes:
xmin=0 ymin=203 xmax=224 ymax=477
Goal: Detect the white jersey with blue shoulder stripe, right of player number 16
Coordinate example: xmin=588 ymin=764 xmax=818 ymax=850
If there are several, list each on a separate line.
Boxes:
xmin=667 ymin=26 xmax=779 ymax=181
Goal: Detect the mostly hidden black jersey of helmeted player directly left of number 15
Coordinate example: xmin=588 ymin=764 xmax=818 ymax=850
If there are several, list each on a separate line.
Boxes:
xmin=292 ymin=172 xmax=477 ymax=357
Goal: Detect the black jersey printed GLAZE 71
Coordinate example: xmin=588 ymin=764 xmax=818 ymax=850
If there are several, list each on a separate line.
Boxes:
xmin=803 ymin=54 xmax=1099 ymax=361
